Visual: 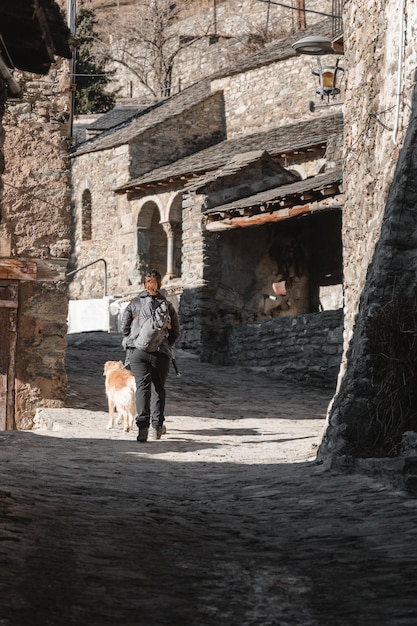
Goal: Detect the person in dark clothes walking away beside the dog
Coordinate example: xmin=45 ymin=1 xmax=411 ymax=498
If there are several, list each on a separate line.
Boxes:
xmin=121 ymin=269 xmax=181 ymax=443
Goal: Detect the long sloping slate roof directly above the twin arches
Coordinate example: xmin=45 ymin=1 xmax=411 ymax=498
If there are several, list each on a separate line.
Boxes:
xmin=115 ymin=113 xmax=343 ymax=193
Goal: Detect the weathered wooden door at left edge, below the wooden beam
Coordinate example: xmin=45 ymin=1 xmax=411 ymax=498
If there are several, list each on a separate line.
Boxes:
xmin=0 ymin=282 xmax=19 ymax=430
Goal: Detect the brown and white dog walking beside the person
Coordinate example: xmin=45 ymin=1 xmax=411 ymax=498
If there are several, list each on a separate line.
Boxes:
xmin=103 ymin=361 xmax=136 ymax=432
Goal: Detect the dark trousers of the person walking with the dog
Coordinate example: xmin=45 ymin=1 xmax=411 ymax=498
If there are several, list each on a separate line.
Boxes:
xmin=130 ymin=348 xmax=169 ymax=428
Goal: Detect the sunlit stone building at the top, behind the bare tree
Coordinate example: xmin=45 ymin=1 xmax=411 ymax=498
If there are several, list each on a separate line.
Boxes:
xmin=105 ymin=0 xmax=334 ymax=104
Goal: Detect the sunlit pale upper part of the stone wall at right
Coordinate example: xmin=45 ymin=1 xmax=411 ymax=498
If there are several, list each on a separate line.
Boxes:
xmin=336 ymin=0 xmax=417 ymax=358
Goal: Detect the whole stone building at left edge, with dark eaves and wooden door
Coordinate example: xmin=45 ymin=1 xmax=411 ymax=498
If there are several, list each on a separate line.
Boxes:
xmin=0 ymin=0 xmax=72 ymax=430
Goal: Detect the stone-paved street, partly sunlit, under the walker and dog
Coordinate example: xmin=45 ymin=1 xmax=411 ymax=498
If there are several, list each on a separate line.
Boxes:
xmin=0 ymin=333 xmax=417 ymax=626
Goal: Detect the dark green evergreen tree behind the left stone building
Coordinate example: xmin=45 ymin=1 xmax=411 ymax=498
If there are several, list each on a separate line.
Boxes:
xmin=75 ymin=9 xmax=116 ymax=115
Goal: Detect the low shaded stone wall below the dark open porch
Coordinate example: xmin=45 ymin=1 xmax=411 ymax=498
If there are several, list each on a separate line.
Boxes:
xmin=226 ymin=309 xmax=343 ymax=388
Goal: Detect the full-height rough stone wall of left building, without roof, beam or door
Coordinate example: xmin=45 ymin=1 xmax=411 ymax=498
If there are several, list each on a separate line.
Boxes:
xmin=0 ymin=61 xmax=70 ymax=428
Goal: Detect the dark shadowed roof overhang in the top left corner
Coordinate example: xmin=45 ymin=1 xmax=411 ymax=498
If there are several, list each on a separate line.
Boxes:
xmin=0 ymin=0 xmax=72 ymax=74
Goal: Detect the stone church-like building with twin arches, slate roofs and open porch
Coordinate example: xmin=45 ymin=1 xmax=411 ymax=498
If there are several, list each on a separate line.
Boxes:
xmin=70 ymin=14 xmax=343 ymax=384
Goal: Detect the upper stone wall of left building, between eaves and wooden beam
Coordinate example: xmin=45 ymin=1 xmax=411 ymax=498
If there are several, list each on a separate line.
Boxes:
xmin=0 ymin=61 xmax=70 ymax=258
